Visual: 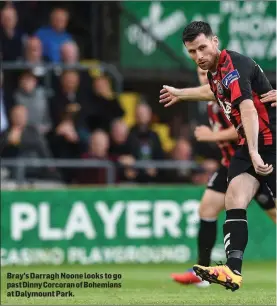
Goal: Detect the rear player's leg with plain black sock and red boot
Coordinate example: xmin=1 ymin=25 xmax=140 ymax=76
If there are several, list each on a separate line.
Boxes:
xmin=171 ymin=166 xmax=228 ymax=287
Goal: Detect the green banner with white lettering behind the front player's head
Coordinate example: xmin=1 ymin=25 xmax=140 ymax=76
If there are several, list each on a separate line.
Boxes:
xmin=120 ymin=0 xmax=276 ymax=71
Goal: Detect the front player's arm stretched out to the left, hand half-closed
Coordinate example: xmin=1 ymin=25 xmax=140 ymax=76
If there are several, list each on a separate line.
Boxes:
xmin=160 ymin=84 xmax=215 ymax=107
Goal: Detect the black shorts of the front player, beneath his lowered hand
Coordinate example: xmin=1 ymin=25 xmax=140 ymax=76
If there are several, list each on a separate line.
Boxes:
xmin=228 ymin=146 xmax=276 ymax=199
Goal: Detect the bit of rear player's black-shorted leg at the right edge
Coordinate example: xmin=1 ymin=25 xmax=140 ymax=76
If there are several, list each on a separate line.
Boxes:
xmin=255 ymin=184 xmax=276 ymax=223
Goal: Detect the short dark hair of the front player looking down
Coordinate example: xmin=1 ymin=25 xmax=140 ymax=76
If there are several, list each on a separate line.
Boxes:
xmin=183 ymin=21 xmax=213 ymax=43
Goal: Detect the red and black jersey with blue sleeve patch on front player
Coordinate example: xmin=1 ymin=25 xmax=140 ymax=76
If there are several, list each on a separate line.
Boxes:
xmin=208 ymin=50 xmax=276 ymax=148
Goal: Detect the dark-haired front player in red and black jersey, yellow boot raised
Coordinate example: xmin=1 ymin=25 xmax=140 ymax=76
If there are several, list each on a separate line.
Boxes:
xmin=158 ymin=21 xmax=276 ymax=291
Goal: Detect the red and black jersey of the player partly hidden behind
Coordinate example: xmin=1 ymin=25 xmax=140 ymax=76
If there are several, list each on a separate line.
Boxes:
xmin=208 ymin=101 xmax=236 ymax=167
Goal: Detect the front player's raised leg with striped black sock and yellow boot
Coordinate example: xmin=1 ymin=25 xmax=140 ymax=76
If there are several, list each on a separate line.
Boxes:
xmin=194 ymin=148 xmax=260 ymax=290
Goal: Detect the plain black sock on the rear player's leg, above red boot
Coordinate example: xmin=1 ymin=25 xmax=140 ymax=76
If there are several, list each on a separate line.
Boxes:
xmin=197 ymin=219 xmax=217 ymax=266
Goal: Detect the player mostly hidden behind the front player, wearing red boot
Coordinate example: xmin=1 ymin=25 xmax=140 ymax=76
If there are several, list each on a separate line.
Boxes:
xmin=171 ymin=67 xmax=276 ymax=287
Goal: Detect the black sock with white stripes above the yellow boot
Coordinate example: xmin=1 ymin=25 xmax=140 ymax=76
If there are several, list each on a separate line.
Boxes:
xmin=223 ymin=209 xmax=248 ymax=274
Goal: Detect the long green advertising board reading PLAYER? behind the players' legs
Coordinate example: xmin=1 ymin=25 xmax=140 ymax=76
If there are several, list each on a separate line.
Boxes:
xmin=1 ymin=186 xmax=276 ymax=266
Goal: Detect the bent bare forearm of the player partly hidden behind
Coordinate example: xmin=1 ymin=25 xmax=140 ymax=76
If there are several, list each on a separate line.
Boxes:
xmin=194 ymin=125 xmax=238 ymax=142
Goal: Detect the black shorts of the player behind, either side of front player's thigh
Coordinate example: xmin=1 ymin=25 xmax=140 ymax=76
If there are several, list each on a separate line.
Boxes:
xmin=207 ymin=165 xmax=276 ymax=210
